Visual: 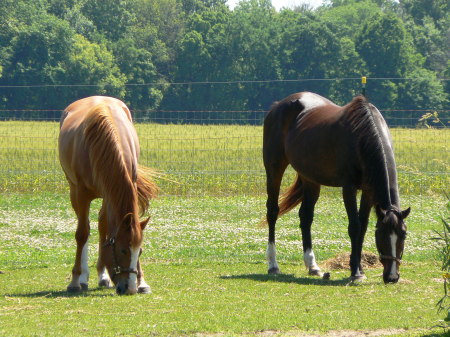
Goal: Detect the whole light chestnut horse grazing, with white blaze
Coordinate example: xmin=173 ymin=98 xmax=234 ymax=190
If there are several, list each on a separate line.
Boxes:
xmin=59 ymin=96 xmax=157 ymax=294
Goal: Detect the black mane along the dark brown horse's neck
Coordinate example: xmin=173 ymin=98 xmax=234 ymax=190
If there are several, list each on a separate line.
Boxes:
xmin=343 ymin=95 xmax=390 ymax=202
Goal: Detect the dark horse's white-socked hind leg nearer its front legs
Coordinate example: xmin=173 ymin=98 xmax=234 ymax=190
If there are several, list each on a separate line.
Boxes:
xmin=299 ymin=183 xmax=323 ymax=277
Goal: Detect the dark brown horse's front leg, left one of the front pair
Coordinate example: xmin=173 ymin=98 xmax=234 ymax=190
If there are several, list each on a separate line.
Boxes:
xmin=342 ymin=186 xmax=365 ymax=281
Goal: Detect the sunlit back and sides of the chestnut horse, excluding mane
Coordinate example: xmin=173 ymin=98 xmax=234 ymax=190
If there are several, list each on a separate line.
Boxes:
xmin=59 ymin=96 xmax=139 ymax=196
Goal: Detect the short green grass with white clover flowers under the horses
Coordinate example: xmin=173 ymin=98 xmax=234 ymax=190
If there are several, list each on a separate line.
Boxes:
xmin=0 ymin=193 xmax=446 ymax=336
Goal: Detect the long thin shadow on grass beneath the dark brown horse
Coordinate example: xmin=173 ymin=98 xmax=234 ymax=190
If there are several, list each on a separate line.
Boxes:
xmin=220 ymin=274 xmax=358 ymax=286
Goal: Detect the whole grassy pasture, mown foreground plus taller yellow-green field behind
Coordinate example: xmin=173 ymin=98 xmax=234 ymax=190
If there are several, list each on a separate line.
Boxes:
xmin=0 ymin=121 xmax=450 ymax=336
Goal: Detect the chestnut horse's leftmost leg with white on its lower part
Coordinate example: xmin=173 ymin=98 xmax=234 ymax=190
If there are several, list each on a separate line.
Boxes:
xmin=67 ymin=185 xmax=92 ymax=292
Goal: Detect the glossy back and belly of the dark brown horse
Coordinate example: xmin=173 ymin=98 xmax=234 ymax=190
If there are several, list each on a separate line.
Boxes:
xmin=266 ymin=92 xmax=368 ymax=186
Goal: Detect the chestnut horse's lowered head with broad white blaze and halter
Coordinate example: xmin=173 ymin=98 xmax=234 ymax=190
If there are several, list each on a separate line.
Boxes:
xmin=102 ymin=214 xmax=148 ymax=295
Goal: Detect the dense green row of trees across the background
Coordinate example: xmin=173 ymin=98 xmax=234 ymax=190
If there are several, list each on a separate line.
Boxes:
xmin=0 ymin=0 xmax=450 ymax=121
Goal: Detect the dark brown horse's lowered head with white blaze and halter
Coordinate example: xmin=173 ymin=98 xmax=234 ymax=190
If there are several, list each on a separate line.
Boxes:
xmin=375 ymin=206 xmax=411 ymax=283
